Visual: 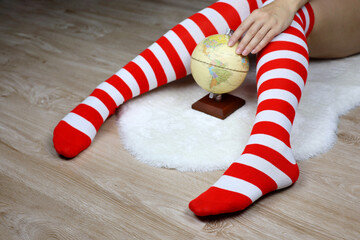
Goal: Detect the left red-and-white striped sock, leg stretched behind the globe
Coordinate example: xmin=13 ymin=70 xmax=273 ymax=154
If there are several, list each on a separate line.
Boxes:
xmin=53 ymin=0 xmax=262 ymax=158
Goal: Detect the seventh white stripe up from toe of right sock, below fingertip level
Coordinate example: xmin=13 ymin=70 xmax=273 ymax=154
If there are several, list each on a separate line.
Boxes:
xmin=256 ymin=50 xmax=309 ymax=71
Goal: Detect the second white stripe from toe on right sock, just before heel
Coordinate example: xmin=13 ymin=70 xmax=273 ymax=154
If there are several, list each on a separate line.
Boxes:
xmin=235 ymin=153 xmax=292 ymax=189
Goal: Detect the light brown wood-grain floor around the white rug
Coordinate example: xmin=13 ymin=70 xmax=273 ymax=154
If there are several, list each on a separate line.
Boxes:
xmin=0 ymin=0 xmax=360 ymax=240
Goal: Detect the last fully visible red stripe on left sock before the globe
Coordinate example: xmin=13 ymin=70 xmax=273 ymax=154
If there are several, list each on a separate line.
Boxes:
xmin=156 ymin=36 xmax=186 ymax=81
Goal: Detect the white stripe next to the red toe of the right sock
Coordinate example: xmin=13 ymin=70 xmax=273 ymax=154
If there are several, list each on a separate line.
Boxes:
xmin=214 ymin=175 xmax=262 ymax=202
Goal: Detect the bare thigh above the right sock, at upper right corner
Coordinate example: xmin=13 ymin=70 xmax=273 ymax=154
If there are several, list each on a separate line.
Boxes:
xmin=308 ymin=0 xmax=360 ymax=58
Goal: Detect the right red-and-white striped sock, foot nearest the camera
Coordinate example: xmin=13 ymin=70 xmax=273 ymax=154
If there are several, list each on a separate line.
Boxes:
xmin=189 ymin=2 xmax=314 ymax=216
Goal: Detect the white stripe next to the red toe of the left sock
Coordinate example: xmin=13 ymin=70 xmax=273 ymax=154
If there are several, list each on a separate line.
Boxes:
xmin=62 ymin=112 xmax=96 ymax=141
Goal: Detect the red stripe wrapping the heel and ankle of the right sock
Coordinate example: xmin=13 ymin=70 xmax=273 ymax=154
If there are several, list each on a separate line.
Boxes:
xmin=243 ymin=144 xmax=299 ymax=183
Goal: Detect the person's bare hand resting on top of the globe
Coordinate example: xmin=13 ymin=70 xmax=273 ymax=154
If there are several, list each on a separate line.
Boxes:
xmin=228 ymin=0 xmax=298 ymax=56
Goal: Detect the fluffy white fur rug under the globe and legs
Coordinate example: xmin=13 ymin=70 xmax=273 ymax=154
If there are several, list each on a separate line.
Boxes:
xmin=118 ymin=54 xmax=360 ymax=171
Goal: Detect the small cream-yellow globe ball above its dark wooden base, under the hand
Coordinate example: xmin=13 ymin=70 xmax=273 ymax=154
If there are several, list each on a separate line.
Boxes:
xmin=190 ymin=34 xmax=249 ymax=94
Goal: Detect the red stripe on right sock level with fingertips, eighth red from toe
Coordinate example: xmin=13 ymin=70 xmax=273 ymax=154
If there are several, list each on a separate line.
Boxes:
xmin=256 ymin=41 xmax=309 ymax=63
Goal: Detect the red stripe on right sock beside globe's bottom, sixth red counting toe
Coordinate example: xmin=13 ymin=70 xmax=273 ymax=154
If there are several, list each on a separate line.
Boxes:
xmin=257 ymin=78 xmax=301 ymax=102
